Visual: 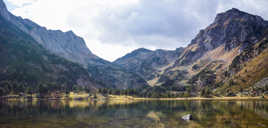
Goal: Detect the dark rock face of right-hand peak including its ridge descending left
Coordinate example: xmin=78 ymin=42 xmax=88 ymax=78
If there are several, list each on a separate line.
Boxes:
xmin=176 ymin=9 xmax=268 ymax=65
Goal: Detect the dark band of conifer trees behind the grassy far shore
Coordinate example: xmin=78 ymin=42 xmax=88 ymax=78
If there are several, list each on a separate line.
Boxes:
xmin=0 ymin=81 xmax=213 ymax=98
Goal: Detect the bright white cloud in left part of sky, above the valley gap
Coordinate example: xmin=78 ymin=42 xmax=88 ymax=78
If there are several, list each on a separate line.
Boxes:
xmin=7 ymin=0 xmax=139 ymax=60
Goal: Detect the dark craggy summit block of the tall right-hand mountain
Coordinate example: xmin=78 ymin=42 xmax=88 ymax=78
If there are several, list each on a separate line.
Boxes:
xmin=191 ymin=8 xmax=268 ymax=50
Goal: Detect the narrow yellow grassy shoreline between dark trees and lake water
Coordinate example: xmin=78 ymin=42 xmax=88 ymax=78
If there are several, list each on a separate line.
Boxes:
xmin=0 ymin=95 xmax=268 ymax=108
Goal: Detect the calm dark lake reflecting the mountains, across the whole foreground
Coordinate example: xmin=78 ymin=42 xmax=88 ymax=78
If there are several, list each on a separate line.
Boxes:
xmin=0 ymin=100 xmax=268 ymax=128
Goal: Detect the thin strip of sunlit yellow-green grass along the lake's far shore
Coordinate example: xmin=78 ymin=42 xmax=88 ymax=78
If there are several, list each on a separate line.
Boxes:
xmin=0 ymin=93 xmax=268 ymax=108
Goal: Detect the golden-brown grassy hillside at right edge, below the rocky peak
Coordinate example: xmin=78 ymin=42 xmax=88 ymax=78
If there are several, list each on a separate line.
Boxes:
xmin=218 ymin=34 xmax=268 ymax=94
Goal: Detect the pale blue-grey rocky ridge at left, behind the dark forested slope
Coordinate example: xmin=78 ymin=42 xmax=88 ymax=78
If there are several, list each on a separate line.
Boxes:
xmin=0 ymin=0 xmax=147 ymax=89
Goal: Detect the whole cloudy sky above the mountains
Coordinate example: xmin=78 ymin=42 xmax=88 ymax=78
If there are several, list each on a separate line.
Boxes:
xmin=4 ymin=0 xmax=268 ymax=61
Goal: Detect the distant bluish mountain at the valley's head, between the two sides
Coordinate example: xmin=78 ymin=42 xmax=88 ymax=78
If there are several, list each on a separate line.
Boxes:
xmin=114 ymin=48 xmax=183 ymax=86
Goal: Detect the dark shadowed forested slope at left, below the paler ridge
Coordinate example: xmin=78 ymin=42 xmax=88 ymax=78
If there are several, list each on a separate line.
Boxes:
xmin=0 ymin=16 xmax=102 ymax=93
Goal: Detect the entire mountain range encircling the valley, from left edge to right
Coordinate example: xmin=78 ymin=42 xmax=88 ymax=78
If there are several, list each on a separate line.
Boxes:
xmin=0 ymin=0 xmax=268 ymax=96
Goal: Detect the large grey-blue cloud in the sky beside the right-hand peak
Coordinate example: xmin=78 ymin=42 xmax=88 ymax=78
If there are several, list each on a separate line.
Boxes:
xmin=78 ymin=0 xmax=268 ymax=49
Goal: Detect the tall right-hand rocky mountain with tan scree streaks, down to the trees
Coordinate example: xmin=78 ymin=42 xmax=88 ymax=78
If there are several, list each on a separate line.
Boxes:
xmin=157 ymin=9 xmax=268 ymax=93
